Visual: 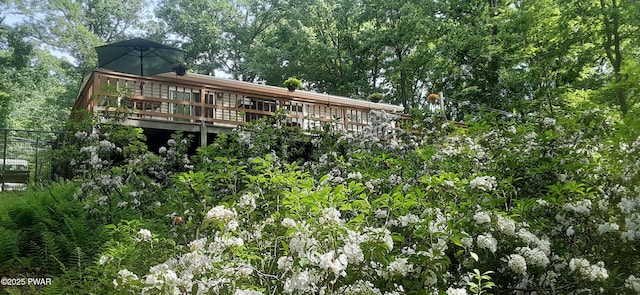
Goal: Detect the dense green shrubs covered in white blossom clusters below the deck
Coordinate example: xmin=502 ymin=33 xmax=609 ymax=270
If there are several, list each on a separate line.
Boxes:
xmin=5 ymin=109 xmax=640 ymax=294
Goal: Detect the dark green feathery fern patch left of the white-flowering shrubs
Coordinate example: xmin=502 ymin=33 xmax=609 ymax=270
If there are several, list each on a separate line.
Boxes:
xmin=0 ymin=183 xmax=105 ymax=277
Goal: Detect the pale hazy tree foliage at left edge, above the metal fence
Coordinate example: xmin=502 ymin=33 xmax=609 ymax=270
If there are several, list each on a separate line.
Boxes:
xmin=0 ymin=24 xmax=77 ymax=130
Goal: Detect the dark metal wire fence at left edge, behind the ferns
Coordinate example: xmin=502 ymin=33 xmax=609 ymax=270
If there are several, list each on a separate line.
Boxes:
xmin=0 ymin=128 xmax=63 ymax=188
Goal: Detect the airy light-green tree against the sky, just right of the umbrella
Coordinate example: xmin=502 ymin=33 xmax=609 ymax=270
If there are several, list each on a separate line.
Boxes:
xmin=157 ymin=0 xmax=284 ymax=82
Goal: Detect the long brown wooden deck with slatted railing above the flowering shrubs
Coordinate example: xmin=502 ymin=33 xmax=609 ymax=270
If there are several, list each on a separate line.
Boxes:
xmin=74 ymin=70 xmax=410 ymax=146
